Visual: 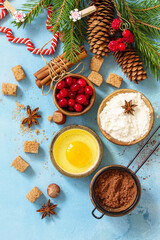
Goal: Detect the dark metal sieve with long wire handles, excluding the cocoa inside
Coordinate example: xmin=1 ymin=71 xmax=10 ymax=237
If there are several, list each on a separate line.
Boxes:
xmin=90 ymin=125 xmax=160 ymax=219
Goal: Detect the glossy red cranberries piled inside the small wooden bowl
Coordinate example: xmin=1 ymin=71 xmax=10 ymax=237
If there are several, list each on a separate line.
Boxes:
xmin=56 ymin=77 xmax=93 ymax=112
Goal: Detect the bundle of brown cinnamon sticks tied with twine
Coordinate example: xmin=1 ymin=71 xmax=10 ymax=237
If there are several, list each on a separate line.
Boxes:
xmin=34 ymin=46 xmax=87 ymax=88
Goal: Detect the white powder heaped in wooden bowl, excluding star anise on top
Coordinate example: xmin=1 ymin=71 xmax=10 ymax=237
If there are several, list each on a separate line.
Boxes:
xmin=100 ymin=93 xmax=150 ymax=142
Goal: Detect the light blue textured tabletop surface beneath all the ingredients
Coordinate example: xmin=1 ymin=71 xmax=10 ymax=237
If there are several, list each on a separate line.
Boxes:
xmin=0 ymin=0 xmax=160 ymax=240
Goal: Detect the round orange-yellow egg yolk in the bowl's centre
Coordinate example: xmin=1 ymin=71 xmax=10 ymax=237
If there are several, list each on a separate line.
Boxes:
xmin=66 ymin=141 xmax=92 ymax=167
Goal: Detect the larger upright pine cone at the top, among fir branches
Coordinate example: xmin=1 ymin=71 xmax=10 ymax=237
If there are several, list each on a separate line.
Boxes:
xmin=88 ymin=0 xmax=114 ymax=58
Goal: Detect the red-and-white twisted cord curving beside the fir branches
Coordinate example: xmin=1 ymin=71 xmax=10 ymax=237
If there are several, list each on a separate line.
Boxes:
xmin=0 ymin=0 xmax=59 ymax=55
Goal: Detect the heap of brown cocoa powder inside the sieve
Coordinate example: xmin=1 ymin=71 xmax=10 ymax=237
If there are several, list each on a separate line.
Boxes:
xmin=94 ymin=169 xmax=137 ymax=211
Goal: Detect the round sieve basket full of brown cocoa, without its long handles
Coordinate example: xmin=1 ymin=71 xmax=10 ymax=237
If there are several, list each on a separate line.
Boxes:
xmin=90 ymin=165 xmax=141 ymax=219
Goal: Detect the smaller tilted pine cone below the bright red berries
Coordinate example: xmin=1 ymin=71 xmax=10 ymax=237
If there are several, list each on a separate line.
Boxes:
xmin=113 ymin=48 xmax=147 ymax=83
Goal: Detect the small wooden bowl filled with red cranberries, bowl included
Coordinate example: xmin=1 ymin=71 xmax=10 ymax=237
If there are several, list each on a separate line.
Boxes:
xmin=53 ymin=74 xmax=96 ymax=116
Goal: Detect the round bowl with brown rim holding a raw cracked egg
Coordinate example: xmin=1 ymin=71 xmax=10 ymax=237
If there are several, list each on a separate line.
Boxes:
xmin=50 ymin=125 xmax=103 ymax=178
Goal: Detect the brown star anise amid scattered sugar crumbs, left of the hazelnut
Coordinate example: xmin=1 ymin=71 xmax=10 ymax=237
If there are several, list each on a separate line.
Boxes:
xmin=22 ymin=106 xmax=41 ymax=128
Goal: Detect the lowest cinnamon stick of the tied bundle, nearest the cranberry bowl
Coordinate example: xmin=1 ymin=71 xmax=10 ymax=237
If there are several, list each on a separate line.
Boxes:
xmin=35 ymin=49 xmax=87 ymax=88
